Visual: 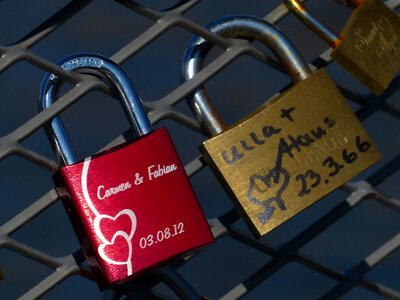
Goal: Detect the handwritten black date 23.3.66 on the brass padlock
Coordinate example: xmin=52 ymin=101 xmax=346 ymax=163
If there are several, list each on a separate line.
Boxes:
xmin=296 ymin=136 xmax=371 ymax=197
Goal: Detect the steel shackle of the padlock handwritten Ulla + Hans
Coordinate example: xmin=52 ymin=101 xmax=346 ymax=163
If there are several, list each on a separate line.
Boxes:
xmin=181 ymin=15 xmax=312 ymax=136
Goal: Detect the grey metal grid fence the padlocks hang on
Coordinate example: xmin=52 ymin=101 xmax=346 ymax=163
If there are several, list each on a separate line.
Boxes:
xmin=0 ymin=0 xmax=400 ymax=299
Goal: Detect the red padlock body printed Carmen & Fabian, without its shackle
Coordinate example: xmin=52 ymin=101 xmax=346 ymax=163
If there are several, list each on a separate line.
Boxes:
xmin=55 ymin=128 xmax=214 ymax=285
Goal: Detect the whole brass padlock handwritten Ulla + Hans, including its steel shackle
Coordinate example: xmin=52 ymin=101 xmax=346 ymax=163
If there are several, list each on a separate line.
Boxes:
xmin=182 ymin=16 xmax=381 ymax=236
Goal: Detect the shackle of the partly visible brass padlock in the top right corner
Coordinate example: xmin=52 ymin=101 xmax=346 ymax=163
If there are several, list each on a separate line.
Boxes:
xmin=284 ymin=0 xmax=341 ymax=48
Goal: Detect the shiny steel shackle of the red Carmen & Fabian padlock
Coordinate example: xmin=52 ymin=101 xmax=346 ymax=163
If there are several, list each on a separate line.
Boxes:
xmin=39 ymin=53 xmax=153 ymax=165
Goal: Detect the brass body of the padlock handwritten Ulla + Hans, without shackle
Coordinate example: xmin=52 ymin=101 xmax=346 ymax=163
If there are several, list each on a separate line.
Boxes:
xmin=202 ymin=70 xmax=380 ymax=236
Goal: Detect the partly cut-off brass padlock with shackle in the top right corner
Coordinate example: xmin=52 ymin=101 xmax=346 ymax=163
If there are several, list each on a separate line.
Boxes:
xmin=284 ymin=0 xmax=400 ymax=95
